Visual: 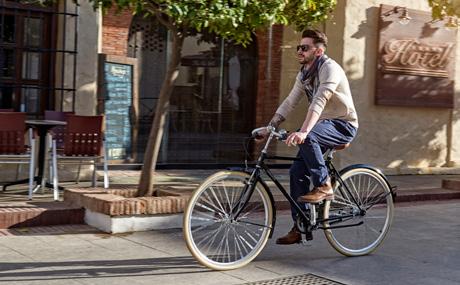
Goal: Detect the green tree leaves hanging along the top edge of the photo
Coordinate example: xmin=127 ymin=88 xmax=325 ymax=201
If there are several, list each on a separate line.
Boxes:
xmin=82 ymin=0 xmax=334 ymax=44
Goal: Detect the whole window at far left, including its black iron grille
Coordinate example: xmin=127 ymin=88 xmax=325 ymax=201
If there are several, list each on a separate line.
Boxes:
xmin=0 ymin=1 xmax=78 ymax=116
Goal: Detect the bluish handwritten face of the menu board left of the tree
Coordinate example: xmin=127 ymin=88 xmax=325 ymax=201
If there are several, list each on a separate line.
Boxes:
xmin=104 ymin=62 xmax=133 ymax=160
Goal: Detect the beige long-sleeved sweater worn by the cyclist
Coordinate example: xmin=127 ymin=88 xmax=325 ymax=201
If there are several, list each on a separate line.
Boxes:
xmin=276 ymin=58 xmax=358 ymax=128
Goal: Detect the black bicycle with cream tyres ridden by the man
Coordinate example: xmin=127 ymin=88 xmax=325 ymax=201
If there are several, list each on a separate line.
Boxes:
xmin=183 ymin=126 xmax=395 ymax=270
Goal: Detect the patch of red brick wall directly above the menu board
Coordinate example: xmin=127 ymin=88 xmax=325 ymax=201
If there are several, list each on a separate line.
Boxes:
xmin=102 ymin=8 xmax=133 ymax=56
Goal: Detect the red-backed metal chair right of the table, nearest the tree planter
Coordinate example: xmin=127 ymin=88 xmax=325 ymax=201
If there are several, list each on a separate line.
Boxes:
xmin=51 ymin=114 xmax=109 ymax=189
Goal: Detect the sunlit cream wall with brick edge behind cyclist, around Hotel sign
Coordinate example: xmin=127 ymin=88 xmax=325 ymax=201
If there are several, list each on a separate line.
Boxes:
xmin=278 ymin=0 xmax=460 ymax=173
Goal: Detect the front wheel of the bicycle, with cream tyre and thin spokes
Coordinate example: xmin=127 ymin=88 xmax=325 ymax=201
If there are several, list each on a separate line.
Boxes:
xmin=183 ymin=171 xmax=273 ymax=270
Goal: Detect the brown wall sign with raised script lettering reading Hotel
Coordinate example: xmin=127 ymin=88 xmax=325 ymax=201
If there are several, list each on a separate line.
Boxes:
xmin=375 ymin=5 xmax=457 ymax=108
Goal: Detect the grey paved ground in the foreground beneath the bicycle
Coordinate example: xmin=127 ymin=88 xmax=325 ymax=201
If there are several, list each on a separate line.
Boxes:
xmin=0 ymin=200 xmax=460 ymax=285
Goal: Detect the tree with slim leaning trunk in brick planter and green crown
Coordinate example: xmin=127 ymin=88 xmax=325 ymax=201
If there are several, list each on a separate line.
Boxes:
xmin=89 ymin=0 xmax=336 ymax=196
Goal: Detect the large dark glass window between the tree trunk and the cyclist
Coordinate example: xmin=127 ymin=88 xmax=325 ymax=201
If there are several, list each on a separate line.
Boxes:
xmin=162 ymin=37 xmax=257 ymax=163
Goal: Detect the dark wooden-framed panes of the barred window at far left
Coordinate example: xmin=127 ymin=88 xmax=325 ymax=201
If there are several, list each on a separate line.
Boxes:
xmin=0 ymin=5 xmax=50 ymax=115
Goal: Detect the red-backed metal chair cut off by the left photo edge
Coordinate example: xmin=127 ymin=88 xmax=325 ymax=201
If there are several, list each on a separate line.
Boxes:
xmin=0 ymin=112 xmax=35 ymax=199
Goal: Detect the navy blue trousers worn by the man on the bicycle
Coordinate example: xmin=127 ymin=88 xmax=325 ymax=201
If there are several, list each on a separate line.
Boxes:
xmin=289 ymin=119 xmax=357 ymax=221
